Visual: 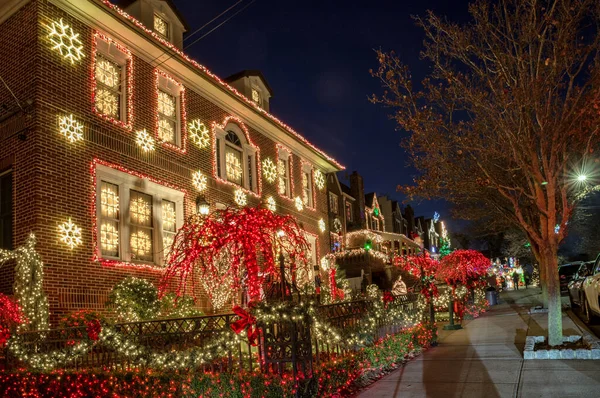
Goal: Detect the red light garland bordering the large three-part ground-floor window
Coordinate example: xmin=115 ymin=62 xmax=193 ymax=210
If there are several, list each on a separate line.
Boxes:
xmin=90 ymin=158 xmax=188 ymax=272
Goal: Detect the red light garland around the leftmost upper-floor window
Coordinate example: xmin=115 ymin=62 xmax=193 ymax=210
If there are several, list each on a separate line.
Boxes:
xmin=91 ymin=32 xmax=133 ymax=130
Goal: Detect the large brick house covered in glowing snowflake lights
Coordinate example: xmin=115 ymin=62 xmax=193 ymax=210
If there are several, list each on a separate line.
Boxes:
xmin=0 ymin=0 xmax=343 ymax=320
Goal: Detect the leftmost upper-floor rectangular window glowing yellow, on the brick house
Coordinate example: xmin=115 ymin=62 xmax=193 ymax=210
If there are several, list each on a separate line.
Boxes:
xmin=94 ymin=34 xmax=131 ymax=127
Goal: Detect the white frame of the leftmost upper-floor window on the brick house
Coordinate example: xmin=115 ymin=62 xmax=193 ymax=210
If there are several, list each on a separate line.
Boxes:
xmin=93 ymin=36 xmax=131 ymax=124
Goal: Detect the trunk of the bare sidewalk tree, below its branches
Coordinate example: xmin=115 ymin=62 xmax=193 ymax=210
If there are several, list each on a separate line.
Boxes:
xmin=540 ymin=247 xmax=562 ymax=346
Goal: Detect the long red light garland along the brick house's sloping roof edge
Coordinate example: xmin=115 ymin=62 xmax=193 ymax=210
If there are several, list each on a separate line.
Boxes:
xmin=102 ymin=0 xmax=344 ymax=170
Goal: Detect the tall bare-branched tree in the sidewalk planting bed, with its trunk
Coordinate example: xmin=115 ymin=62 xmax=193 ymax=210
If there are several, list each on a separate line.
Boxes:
xmin=372 ymin=0 xmax=600 ymax=345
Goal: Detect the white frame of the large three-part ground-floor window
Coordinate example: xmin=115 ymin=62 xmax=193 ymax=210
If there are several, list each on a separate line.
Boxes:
xmin=95 ymin=165 xmax=185 ymax=265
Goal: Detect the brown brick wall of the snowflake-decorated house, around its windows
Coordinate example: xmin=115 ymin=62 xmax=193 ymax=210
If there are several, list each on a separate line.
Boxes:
xmin=0 ymin=0 xmax=329 ymax=320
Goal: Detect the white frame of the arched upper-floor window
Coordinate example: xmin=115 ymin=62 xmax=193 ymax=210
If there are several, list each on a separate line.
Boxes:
xmin=215 ymin=123 xmax=258 ymax=192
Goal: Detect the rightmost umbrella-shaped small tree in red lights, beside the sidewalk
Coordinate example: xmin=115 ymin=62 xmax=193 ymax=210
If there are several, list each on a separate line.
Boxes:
xmin=436 ymin=250 xmax=490 ymax=329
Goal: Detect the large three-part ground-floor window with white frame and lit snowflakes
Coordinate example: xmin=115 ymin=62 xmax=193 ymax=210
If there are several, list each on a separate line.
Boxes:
xmin=96 ymin=165 xmax=184 ymax=264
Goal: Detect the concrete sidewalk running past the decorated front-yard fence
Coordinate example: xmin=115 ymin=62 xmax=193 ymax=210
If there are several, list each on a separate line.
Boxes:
xmin=358 ymin=288 xmax=600 ymax=398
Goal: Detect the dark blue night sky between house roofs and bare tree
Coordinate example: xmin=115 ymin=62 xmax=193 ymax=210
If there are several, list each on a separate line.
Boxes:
xmin=174 ymin=0 xmax=468 ymax=224
